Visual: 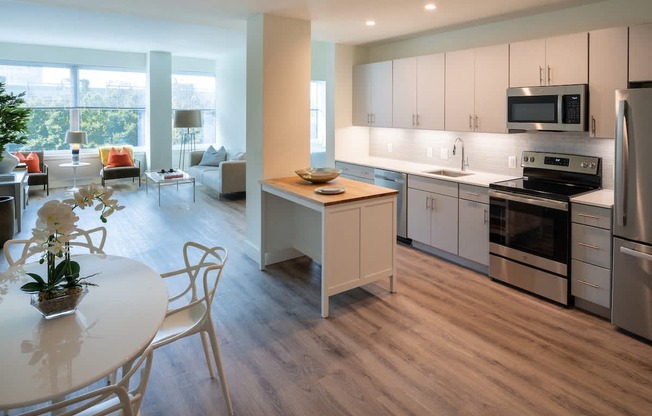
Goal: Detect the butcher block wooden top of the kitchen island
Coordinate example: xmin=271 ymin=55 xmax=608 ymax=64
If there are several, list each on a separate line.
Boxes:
xmin=260 ymin=176 xmax=398 ymax=205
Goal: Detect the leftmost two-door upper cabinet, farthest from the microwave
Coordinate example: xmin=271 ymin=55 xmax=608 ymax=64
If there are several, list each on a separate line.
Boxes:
xmin=353 ymin=61 xmax=392 ymax=127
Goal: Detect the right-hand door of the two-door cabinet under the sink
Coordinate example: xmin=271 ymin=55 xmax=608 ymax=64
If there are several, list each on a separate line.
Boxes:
xmin=432 ymin=194 xmax=458 ymax=254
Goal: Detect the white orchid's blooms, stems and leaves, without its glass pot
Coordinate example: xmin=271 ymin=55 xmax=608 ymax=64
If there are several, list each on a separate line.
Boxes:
xmin=21 ymin=184 xmax=124 ymax=293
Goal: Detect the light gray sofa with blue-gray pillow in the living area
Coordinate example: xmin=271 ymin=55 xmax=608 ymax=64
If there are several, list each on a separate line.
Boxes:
xmin=187 ymin=150 xmax=247 ymax=199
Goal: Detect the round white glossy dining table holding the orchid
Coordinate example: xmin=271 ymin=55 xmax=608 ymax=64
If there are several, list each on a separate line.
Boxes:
xmin=0 ymin=254 xmax=168 ymax=409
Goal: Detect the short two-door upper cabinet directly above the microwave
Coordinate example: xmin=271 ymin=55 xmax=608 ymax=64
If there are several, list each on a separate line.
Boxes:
xmin=509 ymin=32 xmax=589 ymax=87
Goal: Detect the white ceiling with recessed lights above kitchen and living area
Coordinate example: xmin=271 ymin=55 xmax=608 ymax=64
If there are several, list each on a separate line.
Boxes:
xmin=0 ymin=0 xmax=602 ymax=57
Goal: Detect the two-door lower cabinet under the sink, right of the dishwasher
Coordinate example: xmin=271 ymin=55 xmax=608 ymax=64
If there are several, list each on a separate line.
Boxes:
xmin=407 ymin=175 xmax=458 ymax=254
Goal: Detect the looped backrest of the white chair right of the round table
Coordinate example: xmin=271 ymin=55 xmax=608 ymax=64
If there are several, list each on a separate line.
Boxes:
xmin=161 ymin=241 xmax=228 ymax=320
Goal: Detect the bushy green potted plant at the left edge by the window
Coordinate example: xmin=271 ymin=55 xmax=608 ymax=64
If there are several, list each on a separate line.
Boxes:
xmin=0 ymin=81 xmax=32 ymax=174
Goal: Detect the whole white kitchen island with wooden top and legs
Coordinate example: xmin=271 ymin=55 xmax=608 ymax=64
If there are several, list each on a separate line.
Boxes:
xmin=260 ymin=176 xmax=398 ymax=318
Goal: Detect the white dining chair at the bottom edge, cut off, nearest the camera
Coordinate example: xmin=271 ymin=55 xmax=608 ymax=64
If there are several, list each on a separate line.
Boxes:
xmin=13 ymin=347 xmax=153 ymax=416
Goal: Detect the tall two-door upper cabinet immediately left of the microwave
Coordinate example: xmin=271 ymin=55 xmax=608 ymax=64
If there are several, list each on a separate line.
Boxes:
xmin=445 ymin=45 xmax=509 ymax=133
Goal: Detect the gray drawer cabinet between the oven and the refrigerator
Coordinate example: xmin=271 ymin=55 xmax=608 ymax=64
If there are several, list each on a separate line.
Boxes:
xmin=571 ymin=203 xmax=612 ymax=317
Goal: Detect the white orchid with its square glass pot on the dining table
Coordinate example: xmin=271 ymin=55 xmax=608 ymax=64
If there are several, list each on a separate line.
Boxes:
xmin=21 ymin=184 xmax=124 ymax=318
